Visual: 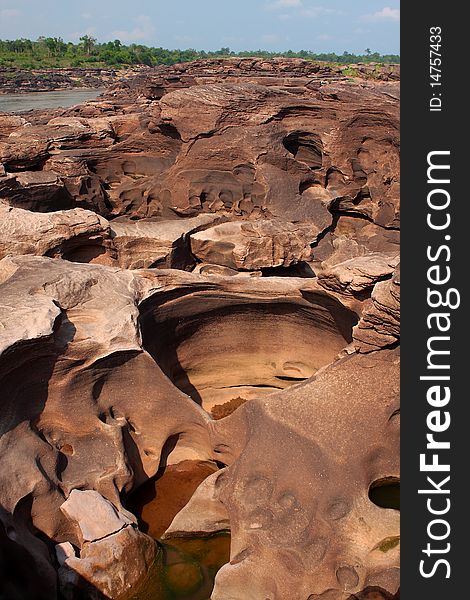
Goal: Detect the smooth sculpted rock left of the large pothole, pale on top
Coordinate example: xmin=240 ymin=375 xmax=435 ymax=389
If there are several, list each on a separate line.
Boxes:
xmin=0 ymin=256 xmax=217 ymax=597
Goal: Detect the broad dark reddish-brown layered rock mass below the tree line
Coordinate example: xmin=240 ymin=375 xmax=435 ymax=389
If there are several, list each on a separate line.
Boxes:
xmin=0 ymin=59 xmax=398 ymax=229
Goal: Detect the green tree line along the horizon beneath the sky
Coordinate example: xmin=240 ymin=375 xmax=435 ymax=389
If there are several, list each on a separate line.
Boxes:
xmin=0 ymin=35 xmax=400 ymax=69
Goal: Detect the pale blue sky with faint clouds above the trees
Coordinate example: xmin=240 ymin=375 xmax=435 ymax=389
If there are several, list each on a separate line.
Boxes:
xmin=0 ymin=0 xmax=400 ymax=53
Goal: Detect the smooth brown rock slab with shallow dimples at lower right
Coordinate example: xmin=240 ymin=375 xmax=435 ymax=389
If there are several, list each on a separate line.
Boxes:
xmin=211 ymin=351 xmax=399 ymax=600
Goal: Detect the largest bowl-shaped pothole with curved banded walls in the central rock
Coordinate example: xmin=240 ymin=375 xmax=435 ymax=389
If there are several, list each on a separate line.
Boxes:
xmin=141 ymin=292 xmax=357 ymax=411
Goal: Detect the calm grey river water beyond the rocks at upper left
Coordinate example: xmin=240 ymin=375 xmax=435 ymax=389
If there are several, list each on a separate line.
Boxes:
xmin=0 ymin=90 xmax=103 ymax=112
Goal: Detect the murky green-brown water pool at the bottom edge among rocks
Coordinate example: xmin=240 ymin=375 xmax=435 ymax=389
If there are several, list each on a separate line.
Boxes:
xmin=129 ymin=533 xmax=230 ymax=600
